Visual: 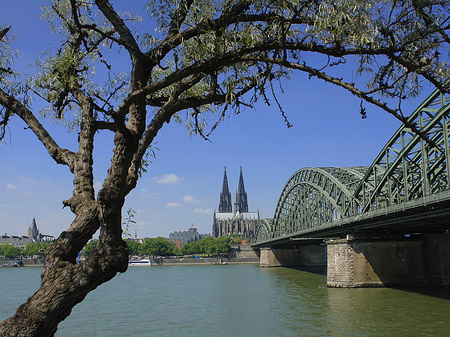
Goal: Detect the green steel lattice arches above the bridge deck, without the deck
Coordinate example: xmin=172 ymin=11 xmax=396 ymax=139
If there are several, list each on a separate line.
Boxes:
xmin=257 ymin=90 xmax=450 ymax=242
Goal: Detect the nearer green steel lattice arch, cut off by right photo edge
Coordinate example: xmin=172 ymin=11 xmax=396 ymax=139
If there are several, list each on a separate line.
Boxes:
xmin=354 ymin=91 xmax=450 ymax=216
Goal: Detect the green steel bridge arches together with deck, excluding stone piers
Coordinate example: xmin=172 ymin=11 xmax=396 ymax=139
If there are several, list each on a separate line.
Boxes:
xmin=252 ymin=91 xmax=450 ymax=248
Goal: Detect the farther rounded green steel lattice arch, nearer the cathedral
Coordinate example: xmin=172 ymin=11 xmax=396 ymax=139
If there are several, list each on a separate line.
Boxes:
xmin=273 ymin=167 xmax=367 ymax=237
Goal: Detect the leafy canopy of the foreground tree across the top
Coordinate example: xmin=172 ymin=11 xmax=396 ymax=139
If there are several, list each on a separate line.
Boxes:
xmin=0 ymin=0 xmax=450 ymax=142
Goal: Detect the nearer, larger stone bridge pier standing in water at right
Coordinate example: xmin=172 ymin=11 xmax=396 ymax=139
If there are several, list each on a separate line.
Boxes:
xmin=327 ymin=234 xmax=450 ymax=288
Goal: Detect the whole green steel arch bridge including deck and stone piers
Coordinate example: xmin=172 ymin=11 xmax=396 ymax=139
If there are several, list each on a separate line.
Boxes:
xmin=252 ymin=87 xmax=450 ymax=286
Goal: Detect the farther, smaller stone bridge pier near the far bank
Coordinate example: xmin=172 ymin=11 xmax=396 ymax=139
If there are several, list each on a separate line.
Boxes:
xmin=259 ymin=245 xmax=327 ymax=267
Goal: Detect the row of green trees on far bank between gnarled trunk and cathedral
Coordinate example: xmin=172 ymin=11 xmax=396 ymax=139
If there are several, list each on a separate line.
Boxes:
xmin=83 ymin=237 xmax=231 ymax=256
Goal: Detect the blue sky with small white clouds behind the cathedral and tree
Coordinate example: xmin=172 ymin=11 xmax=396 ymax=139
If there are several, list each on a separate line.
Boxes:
xmin=0 ymin=0 xmax=431 ymax=237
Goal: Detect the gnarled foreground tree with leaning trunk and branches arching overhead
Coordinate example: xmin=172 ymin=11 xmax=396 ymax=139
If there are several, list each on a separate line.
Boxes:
xmin=0 ymin=0 xmax=450 ymax=336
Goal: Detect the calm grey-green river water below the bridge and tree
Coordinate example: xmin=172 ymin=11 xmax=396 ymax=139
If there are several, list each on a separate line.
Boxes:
xmin=0 ymin=265 xmax=450 ymax=337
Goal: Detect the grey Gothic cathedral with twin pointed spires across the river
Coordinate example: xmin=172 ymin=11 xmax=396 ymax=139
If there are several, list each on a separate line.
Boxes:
xmin=212 ymin=167 xmax=259 ymax=238
